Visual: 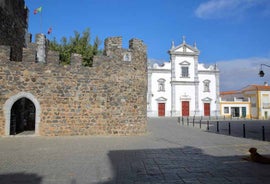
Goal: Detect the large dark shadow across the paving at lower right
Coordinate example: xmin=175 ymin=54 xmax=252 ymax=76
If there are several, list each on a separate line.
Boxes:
xmin=101 ymin=146 xmax=270 ymax=184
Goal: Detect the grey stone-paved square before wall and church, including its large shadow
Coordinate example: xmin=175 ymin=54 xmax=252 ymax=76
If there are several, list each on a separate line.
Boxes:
xmin=0 ymin=118 xmax=270 ymax=184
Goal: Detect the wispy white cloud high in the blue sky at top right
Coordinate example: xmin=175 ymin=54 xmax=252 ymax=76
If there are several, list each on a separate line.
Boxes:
xmin=195 ymin=0 xmax=270 ymax=19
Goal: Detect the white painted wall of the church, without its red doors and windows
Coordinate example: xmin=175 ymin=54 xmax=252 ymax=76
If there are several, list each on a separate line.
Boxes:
xmin=147 ymin=38 xmax=219 ymax=117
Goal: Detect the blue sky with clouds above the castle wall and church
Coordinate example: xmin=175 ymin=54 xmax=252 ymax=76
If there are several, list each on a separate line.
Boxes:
xmin=25 ymin=0 xmax=270 ymax=90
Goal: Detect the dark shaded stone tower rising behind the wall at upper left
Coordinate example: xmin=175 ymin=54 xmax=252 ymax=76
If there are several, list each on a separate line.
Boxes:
xmin=0 ymin=0 xmax=28 ymax=61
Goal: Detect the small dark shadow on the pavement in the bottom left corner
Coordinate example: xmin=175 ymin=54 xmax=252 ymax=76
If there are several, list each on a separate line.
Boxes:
xmin=0 ymin=173 xmax=42 ymax=184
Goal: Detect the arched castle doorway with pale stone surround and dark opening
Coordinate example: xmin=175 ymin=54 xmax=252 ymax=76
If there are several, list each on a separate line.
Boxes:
xmin=4 ymin=92 xmax=41 ymax=136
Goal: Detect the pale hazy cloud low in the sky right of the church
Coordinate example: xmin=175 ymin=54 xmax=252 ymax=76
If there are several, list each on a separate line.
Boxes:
xmin=217 ymin=58 xmax=270 ymax=91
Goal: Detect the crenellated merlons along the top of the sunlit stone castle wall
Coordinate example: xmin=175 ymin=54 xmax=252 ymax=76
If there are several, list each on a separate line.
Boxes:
xmin=0 ymin=34 xmax=146 ymax=67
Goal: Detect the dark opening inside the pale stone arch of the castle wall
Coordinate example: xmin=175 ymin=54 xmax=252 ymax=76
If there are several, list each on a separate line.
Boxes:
xmin=10 ymin=98 xmax=36 ymax=135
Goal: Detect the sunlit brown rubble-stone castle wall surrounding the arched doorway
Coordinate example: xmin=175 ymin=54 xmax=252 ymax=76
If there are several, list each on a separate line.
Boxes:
xmin=0 ymin=34 xmax=147 ymax=136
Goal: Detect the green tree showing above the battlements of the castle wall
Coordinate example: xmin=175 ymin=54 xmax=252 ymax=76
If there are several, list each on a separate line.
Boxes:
xmin=49 ymin=28 xmax=101 ymax=66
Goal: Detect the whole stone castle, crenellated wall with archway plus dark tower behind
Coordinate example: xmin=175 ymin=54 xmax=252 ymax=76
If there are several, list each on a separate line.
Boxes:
xmin=0 ymin=0 xmax=147 ymax=136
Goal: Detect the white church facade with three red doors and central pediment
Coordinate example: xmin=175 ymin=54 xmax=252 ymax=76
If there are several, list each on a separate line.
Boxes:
xmin=147 ymin=38 xmax=220 ymax=117
